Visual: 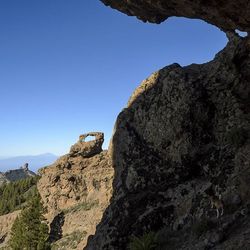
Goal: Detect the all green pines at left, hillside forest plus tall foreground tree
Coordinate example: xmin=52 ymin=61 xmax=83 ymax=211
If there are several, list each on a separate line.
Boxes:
xmin=0 ymin=176 xmax=50 ymax=250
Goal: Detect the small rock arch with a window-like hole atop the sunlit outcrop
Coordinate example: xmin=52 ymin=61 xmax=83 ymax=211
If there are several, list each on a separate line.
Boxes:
xmin=69 ymin=132 xmax=104 ymax=157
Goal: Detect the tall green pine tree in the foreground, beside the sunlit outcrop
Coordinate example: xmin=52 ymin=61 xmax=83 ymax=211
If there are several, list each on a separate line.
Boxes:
xmin=9 ymin=189 xmax=50 ymax=250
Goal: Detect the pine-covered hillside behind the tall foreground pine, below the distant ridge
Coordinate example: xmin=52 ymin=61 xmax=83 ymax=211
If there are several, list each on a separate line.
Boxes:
xmin=0 ymin=176 xmax=39 ymax=215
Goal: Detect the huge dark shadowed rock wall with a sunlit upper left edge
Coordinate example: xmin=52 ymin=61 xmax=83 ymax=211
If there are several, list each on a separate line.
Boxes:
xmin=85 ymin=34 xmax=250 ymax=250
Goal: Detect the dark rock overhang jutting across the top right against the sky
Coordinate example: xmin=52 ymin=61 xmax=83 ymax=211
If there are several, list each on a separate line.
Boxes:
xmin=101 ymin=0 xmax=250 ymax=31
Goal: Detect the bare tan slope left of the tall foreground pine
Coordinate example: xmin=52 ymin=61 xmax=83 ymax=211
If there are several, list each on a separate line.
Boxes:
xmin=0 ymin=210 xmax=21 ymax=249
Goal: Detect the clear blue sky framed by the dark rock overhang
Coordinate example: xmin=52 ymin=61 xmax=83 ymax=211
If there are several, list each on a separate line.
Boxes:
xmin=0 ymin=0 xmax=227 ymax=157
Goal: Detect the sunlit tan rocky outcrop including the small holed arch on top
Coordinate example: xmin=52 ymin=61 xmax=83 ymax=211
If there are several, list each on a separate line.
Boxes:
xmin=38 ymin=133 xmax=113 ymax=250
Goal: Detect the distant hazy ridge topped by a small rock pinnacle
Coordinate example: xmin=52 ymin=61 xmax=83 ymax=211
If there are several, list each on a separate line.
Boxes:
xmin=0 ymin=163 xmax=36 ymax=185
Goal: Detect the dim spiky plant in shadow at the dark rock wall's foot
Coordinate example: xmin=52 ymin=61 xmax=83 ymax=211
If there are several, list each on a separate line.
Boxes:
xmin=129 ymin=232 xmax=158 ymax=250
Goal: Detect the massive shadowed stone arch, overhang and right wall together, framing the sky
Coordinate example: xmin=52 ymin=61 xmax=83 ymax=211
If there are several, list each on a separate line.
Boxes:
xmin=85 ymin=0 xmax=250 ymax=250
